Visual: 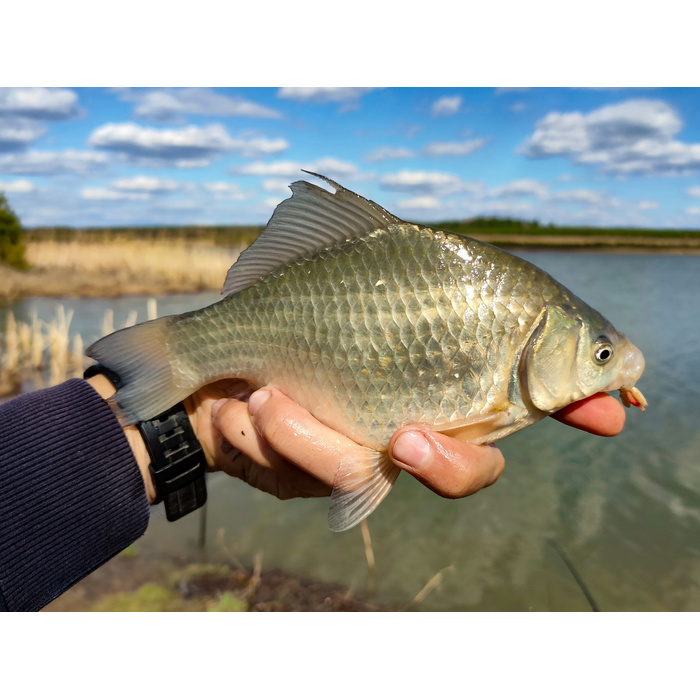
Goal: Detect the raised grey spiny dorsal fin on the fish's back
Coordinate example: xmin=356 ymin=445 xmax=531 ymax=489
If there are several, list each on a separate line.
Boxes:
xmin=221 ymin=170 xmax=403 ymax=296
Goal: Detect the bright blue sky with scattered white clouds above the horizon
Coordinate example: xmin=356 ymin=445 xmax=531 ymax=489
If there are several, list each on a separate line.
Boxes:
xmin=0 ymin=87 xmax=700 ymax=228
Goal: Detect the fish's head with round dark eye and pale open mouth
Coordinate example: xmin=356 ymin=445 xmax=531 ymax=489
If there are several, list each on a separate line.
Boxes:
xmin=520 ymin=305 xmax=646 ymax=413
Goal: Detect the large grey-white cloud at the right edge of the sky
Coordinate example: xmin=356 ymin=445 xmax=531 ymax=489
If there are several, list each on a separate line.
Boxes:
xmin=519 ymin=100 xmax=700 ymax=175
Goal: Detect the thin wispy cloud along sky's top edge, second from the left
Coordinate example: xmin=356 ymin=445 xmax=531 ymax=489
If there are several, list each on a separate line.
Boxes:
xmin=120 ymin=88 xmax=282 ymax=123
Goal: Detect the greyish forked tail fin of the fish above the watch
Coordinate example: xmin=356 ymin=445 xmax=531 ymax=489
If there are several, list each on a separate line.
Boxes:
xmin=86 ymin=316 xmax=192 ymax=425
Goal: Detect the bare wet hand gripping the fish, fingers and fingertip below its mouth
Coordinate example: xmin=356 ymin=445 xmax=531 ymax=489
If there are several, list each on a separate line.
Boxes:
xmin=185 ymin=380 xmax=625 ymax=499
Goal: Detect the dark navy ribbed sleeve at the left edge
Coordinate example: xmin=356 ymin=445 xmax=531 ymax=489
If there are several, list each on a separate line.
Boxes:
xmin=0 ymin=379 xmax=149 ymax=610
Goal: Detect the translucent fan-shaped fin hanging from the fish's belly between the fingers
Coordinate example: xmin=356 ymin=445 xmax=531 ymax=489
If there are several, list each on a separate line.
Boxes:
xmin=328 ymin=448 xmax=401 ymax=532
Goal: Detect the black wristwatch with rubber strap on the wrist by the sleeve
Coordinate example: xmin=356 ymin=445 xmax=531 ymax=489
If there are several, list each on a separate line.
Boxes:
xmin=83 ymin=365 xmax=207 ymax=521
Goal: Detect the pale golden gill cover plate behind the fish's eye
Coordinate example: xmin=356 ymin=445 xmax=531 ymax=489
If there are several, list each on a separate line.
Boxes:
xmin=520 ymin=306 xmax=583 ymax=413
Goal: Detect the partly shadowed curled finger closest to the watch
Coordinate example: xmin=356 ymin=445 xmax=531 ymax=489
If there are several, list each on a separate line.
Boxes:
xmin=212 ymin=399 xmax=331 ymax=499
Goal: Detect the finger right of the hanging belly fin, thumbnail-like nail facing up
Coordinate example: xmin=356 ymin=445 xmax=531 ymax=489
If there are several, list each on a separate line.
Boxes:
xmin=389 ymin=425 xmax=505 ymax=498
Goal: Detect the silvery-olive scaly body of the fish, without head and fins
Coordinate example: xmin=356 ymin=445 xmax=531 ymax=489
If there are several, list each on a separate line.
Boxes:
xmin=168 ymin=224 xmax=577 ymax=447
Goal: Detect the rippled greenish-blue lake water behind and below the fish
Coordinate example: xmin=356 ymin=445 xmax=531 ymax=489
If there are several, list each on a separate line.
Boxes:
xmin=0 ymin=251 xmax=700 ymax=610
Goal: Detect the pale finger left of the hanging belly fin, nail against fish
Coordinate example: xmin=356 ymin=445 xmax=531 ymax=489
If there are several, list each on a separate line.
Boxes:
xmin=248 ymin=387 xmax=366 ymax=485
